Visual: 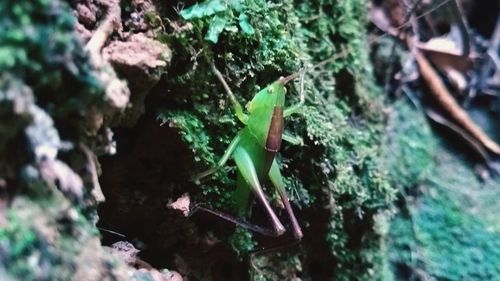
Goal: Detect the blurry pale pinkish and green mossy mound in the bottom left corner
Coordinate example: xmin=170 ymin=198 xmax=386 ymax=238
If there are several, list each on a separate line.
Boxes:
xmin=0 ymin=186 xmax=132 ymax=280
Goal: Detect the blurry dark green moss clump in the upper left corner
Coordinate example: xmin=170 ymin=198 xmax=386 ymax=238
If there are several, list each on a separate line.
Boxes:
xmin=0 ymin=0 xmax=104 ymax=140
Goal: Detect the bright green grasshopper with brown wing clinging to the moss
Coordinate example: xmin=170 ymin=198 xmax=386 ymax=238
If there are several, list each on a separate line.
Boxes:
xmin=191 ymin=63 xmax=305 ymax=241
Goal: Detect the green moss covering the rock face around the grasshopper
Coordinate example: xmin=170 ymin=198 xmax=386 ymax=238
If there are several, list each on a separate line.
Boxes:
xmin=157 ymin=1 xmax=394 ymax=280
